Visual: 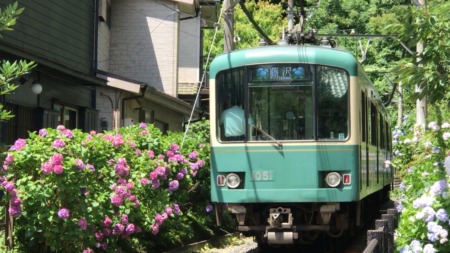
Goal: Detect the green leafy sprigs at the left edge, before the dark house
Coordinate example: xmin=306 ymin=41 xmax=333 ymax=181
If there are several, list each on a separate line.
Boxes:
xmin=0 ymin=2 xmax=36 ymax=121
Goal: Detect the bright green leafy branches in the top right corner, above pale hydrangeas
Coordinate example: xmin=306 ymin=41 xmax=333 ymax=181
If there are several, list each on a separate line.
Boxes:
xmin=386 ymin=0 xmax=450 ymax=106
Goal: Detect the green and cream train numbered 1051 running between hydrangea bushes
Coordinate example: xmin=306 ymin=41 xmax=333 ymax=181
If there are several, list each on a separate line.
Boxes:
xmin=209 ymin=42 xmax=393 ymax=245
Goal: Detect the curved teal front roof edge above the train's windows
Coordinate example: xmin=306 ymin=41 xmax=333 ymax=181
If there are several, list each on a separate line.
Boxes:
xmin=210 ymin=45 xmax=358 ymax=77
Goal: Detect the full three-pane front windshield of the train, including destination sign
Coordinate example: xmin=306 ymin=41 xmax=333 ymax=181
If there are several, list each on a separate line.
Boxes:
xmin=216 ymin=64 xmax=349 ymax=142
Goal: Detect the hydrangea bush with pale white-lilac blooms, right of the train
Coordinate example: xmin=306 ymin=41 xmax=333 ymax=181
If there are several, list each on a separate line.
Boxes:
xmin=391 ymin=116 xmax=450 ymax=253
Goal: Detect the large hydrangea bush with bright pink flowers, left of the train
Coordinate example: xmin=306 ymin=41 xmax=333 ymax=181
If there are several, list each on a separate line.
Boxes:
xmin=0 ymin=123 xmax=216 ymax=253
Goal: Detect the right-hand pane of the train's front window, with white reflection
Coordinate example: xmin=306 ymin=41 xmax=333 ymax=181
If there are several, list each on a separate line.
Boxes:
xmin=317 ymin=66 xmax=349 ymax=140
